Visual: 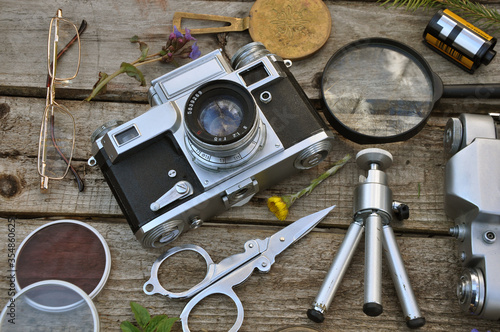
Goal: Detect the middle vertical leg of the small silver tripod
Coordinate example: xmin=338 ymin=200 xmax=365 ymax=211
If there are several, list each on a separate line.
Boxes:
xmin=363 ymin=213 xmax=383 ymax=316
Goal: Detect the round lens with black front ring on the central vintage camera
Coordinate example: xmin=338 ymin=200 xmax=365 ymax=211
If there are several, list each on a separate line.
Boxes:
xmin=184 ymin=80 xmax=266 ymax=169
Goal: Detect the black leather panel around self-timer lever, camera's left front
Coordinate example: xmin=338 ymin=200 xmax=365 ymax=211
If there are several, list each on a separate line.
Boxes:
xmin=95 ymin=133 xmax=203 ymax=233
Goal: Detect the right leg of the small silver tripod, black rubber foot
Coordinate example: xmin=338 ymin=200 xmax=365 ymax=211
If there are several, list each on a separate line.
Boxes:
xmin=383 ymin=225 xmax=425 ymax=328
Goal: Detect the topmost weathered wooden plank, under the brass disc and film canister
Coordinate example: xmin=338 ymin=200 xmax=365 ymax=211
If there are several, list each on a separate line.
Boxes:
xmin=0 ymin=0 xmax=500 ymax=102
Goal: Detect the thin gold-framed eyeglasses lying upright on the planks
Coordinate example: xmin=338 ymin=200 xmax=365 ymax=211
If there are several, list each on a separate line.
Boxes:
xmin=38 ymin=9 xmax=87 ymax=192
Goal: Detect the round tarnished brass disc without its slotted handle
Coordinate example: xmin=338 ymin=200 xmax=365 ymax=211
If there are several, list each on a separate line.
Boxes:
xmin=249 ymin=0 xmax=332 ymax=60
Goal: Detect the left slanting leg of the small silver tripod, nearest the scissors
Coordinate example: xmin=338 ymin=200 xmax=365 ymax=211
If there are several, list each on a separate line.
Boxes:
xmin=307 ymin=221 xmax=363 ymax=323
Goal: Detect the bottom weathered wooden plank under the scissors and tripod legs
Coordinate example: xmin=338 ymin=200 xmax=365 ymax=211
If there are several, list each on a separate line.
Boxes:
xmin=0 ymin=219 xmax=498 ymax=331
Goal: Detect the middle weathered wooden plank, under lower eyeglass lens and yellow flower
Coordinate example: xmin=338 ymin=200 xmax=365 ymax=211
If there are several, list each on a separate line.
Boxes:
xmin=0 ymin=97 xmax=452 ymax=234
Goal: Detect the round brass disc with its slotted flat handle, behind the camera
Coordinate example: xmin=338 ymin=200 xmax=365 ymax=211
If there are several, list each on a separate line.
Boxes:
xmin=173 ymin=0 xmax=332 ymax=60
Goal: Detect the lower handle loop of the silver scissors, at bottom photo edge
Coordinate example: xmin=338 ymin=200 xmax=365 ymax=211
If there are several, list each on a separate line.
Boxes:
xmin=180 ymin=285 xmax=245 ymax=332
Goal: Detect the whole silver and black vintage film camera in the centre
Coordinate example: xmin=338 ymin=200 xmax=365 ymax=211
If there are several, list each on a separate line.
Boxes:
xmin=89 ymin=43 xmax=334 ymax=247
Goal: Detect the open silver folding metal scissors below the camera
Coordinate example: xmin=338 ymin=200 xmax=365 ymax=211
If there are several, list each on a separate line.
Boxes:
xmin=143 ymin=206 xmax=335 ymax=332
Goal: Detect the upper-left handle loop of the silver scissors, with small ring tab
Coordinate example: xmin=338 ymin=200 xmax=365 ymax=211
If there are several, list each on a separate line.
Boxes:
xmin=143 ymin=244 xmax=214 ymax=299
